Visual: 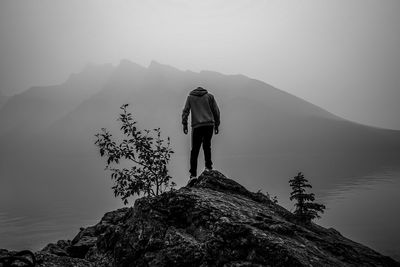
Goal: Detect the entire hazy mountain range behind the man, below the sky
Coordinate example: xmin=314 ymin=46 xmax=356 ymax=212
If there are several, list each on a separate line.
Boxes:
xmin=0 ymin=60 xmax=400 ymax=224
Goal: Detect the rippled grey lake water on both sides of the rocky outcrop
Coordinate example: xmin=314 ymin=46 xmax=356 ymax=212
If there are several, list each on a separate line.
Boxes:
xmin=0 ymin=168 xmax=400 ymax=260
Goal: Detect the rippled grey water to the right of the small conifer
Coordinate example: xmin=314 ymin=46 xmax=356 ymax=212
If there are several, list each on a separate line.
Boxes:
xmin=318 ymin=168 xmax=400 ymax=260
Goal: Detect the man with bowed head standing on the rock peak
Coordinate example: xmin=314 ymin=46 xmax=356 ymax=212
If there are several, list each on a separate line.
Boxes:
xmin=182 ymin=87 xmax=220 ymax=184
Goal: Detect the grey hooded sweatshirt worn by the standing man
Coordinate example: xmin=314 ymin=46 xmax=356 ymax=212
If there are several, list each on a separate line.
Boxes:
xmin=182 ymin=87 xmax=220 ymax=128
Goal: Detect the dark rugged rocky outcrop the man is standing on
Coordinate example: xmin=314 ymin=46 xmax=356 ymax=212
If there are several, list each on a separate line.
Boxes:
xmin=1 ymin=171 xmax=400 ymax=266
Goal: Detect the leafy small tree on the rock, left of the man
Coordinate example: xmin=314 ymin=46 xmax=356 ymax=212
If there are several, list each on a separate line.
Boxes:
xmin=95 ymin=104 xmax=175 ymax=204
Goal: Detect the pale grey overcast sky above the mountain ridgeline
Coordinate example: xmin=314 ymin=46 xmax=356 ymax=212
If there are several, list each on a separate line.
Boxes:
xmin=0 ymin=0 xmax=400 ymax=130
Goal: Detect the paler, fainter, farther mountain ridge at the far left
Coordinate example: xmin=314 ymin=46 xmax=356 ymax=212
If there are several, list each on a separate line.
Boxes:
xmin=0 ymin=65 xmax=113 ymax=138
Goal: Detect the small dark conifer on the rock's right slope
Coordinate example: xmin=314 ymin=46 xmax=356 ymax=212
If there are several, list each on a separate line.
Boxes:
xmin=289 ymin=172 xmax=325 ymax=223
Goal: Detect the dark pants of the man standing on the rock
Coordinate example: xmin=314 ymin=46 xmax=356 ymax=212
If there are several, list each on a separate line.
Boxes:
xmin=189 ymin=126 xmax=214 ymax=176
